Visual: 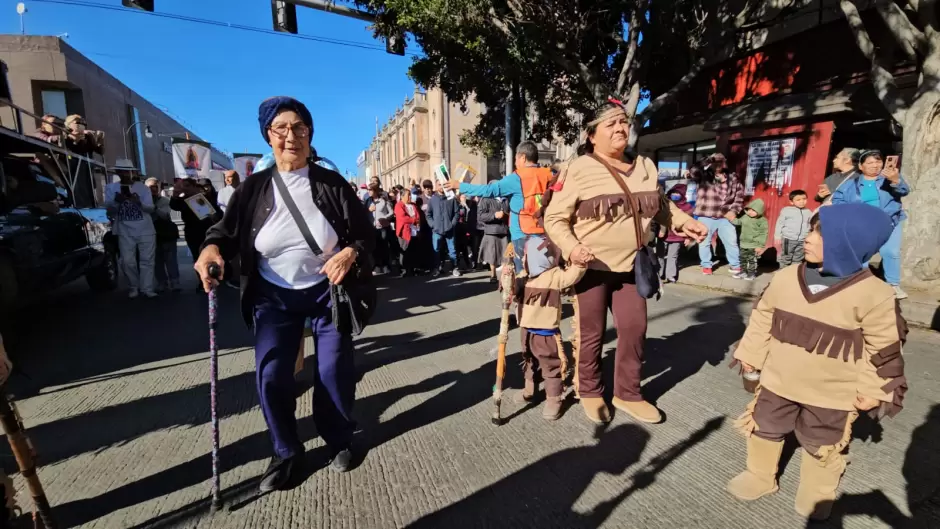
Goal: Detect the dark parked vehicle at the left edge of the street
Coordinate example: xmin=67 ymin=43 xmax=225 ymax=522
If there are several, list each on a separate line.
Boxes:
xmin=0 ymin=127 xmax=118 ymax=326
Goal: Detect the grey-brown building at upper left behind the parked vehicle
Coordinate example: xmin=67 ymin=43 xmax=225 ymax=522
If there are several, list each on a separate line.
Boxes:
xmin=0 ymin=35 xmax=232 ymax=182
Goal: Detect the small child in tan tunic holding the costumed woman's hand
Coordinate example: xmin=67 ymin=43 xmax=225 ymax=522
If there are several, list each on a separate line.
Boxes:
xmin=516 ymin=236 xmax=587 ymax=421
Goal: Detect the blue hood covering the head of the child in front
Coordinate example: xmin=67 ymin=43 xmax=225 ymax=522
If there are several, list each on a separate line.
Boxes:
xmin=819 ymin=203 xmax=894 ymax=277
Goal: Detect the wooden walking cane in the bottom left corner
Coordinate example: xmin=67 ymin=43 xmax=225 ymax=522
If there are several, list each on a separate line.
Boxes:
xmin=0 ymin=387 xmax=58 ymax=529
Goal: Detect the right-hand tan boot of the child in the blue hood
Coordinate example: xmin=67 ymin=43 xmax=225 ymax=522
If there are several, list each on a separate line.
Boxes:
xmin=794 ymin=450 xmax=845 ymax=520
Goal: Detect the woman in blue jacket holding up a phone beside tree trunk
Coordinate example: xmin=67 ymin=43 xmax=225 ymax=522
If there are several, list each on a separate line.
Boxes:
xmin=832 ymin=149 xmax=911 ymax=299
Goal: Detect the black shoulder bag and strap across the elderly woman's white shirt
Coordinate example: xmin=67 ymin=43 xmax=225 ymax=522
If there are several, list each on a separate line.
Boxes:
xmin=273 ymin=170 xmax=375 ymax=336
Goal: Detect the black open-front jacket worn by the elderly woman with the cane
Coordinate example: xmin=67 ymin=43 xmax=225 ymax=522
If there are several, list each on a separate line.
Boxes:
xmin=202 ymin=163 xmax=375 ymax=326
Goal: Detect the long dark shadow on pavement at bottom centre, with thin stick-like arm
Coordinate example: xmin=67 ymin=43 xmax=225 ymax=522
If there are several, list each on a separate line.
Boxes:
xmin=409 ymin=417 xmax=724 ymax=529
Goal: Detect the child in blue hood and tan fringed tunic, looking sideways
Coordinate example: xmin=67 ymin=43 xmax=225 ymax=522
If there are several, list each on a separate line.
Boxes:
xmin=728 ymin=204 xmax=907 ymax=520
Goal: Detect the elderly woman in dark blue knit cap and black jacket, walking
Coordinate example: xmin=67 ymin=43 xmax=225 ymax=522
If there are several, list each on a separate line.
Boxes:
xmin=195 ymin=97 xmax=375 ymax=492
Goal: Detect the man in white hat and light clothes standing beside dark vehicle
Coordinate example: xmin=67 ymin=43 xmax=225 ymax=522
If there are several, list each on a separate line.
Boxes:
xmin=104 ymin=159 xmax=157 ymax=298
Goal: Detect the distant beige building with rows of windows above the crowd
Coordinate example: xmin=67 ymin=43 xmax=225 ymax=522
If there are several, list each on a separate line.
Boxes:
xmin=366 ymin=88 xmax=487 ymax=188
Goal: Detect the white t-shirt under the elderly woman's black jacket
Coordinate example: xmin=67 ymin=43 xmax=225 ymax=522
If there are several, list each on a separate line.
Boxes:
xmin=255 ymin=167 xmax=339 ymax=290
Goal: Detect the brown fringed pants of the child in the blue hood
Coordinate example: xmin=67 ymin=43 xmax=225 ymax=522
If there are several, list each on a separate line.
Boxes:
xmin=754 ymin=388 xmax=850 ymax=455
